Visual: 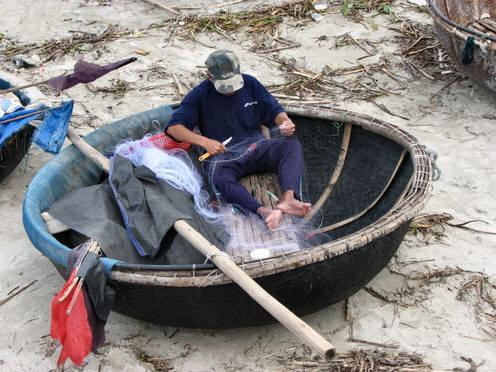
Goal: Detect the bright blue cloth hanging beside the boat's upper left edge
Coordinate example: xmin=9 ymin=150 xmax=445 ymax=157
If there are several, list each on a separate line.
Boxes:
xmin=34 ymin=101 xmax=74 ymax=154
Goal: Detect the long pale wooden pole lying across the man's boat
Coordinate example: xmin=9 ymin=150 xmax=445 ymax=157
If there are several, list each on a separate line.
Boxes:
xmin=61 ymin=127 xmax=335 ymax=361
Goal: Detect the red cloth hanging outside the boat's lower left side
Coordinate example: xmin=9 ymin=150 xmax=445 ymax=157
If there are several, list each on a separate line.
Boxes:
xmin=50 ymin=270 xmax=93 ymax=366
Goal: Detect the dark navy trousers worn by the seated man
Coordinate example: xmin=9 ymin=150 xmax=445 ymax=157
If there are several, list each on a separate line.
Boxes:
xmin=212 ymin=137 xmax=304 ymax=213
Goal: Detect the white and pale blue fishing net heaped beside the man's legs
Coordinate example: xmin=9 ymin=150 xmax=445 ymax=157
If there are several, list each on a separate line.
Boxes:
xmin=115 ymin=131 xmax=322 ymax=259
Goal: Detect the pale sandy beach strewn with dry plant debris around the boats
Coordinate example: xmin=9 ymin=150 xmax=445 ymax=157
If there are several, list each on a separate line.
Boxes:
xmin=0 ymin=0 xmax=496 ymax=371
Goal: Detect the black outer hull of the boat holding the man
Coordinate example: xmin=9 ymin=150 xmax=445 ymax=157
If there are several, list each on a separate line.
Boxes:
xmin=51 ymin=223 xmax=408 ymax=329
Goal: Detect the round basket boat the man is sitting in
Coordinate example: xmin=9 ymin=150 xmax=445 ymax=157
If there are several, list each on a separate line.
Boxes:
xmin=23 ymin=106 xmax=433 ymax=328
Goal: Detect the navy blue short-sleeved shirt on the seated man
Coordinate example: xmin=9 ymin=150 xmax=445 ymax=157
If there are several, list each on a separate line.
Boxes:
xmin=167 ymin=74 xmax=284 ymax=145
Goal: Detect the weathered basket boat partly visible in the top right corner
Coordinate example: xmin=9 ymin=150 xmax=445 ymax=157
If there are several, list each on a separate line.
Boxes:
xmin=427 ymin=0 xmax=496 ymax=92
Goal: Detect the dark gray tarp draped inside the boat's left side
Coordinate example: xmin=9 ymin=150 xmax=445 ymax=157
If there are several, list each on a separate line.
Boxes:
xmin=49 ymin=156 xmax=226 ymax=264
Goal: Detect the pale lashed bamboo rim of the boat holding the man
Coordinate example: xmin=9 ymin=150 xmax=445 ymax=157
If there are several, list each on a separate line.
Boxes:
xmin=107 ymin=105 xmax=434 ymax=287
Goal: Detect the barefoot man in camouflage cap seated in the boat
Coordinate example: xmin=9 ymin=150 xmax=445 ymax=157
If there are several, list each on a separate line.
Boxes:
xmin=166 ymin=50 xmax=311 ymax=230
